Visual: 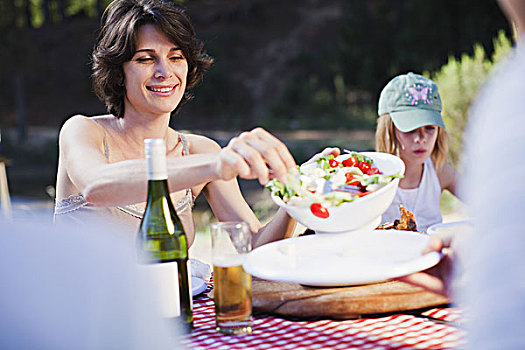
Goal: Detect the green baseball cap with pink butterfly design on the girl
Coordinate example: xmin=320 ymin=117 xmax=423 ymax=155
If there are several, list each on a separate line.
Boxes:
xmin=377 ymin=73 xmax=445 ymax=132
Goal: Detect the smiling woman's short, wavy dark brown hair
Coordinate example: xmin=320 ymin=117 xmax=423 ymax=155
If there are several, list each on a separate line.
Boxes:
xmin=92 ymin=0 xmax=213 ymax=118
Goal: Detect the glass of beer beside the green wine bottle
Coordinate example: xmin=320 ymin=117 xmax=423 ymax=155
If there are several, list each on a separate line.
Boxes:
xmin=210 ymin=222 xmax=253 ymax=334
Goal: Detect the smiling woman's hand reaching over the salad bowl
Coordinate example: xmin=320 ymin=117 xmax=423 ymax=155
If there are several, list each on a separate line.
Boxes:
xmin=216 ymin=128 xmax=297 ymax=185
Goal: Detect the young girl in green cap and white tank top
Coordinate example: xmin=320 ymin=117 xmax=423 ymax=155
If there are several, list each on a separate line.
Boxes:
xmin=376 ymin=73 xmax=457 ymax=231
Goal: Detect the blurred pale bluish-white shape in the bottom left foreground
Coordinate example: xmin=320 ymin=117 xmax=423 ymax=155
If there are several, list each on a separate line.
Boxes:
xmin=0 ymin=214 xmax=182 ymax=350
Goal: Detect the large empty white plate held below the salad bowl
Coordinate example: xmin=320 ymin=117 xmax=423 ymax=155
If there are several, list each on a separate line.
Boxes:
xmin=243 ymin=230 xmax=441 ymax=286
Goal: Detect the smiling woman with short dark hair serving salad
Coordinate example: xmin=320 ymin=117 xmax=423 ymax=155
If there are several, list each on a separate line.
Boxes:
xmin=55 ymin=0 xmax=296 ymax=246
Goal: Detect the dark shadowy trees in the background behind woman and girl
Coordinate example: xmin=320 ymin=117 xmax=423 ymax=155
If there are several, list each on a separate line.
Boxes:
xmin=0 ymin=0 xmax=508 ymax=130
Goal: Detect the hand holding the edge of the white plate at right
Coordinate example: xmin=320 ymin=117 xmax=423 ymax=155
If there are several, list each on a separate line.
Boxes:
xmin=396 ymin=233 xmax=454 ymax=297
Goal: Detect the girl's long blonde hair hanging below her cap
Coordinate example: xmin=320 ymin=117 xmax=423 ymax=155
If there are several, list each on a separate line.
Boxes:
xmin=376 ymin=113 xmax=448 ymax=170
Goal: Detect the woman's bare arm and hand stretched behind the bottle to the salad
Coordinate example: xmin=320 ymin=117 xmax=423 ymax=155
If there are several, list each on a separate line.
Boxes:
xmin=57 ymin=116 xmax=296 ymax=211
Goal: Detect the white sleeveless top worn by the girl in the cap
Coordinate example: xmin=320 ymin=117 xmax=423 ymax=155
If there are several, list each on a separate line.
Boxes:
xmin=381 ymin=158 xmax=443 ymax=232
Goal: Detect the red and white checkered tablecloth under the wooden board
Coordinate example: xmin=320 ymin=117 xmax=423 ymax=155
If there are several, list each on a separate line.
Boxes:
xmin=183 ymin=288 xmax=466 ymax=350
